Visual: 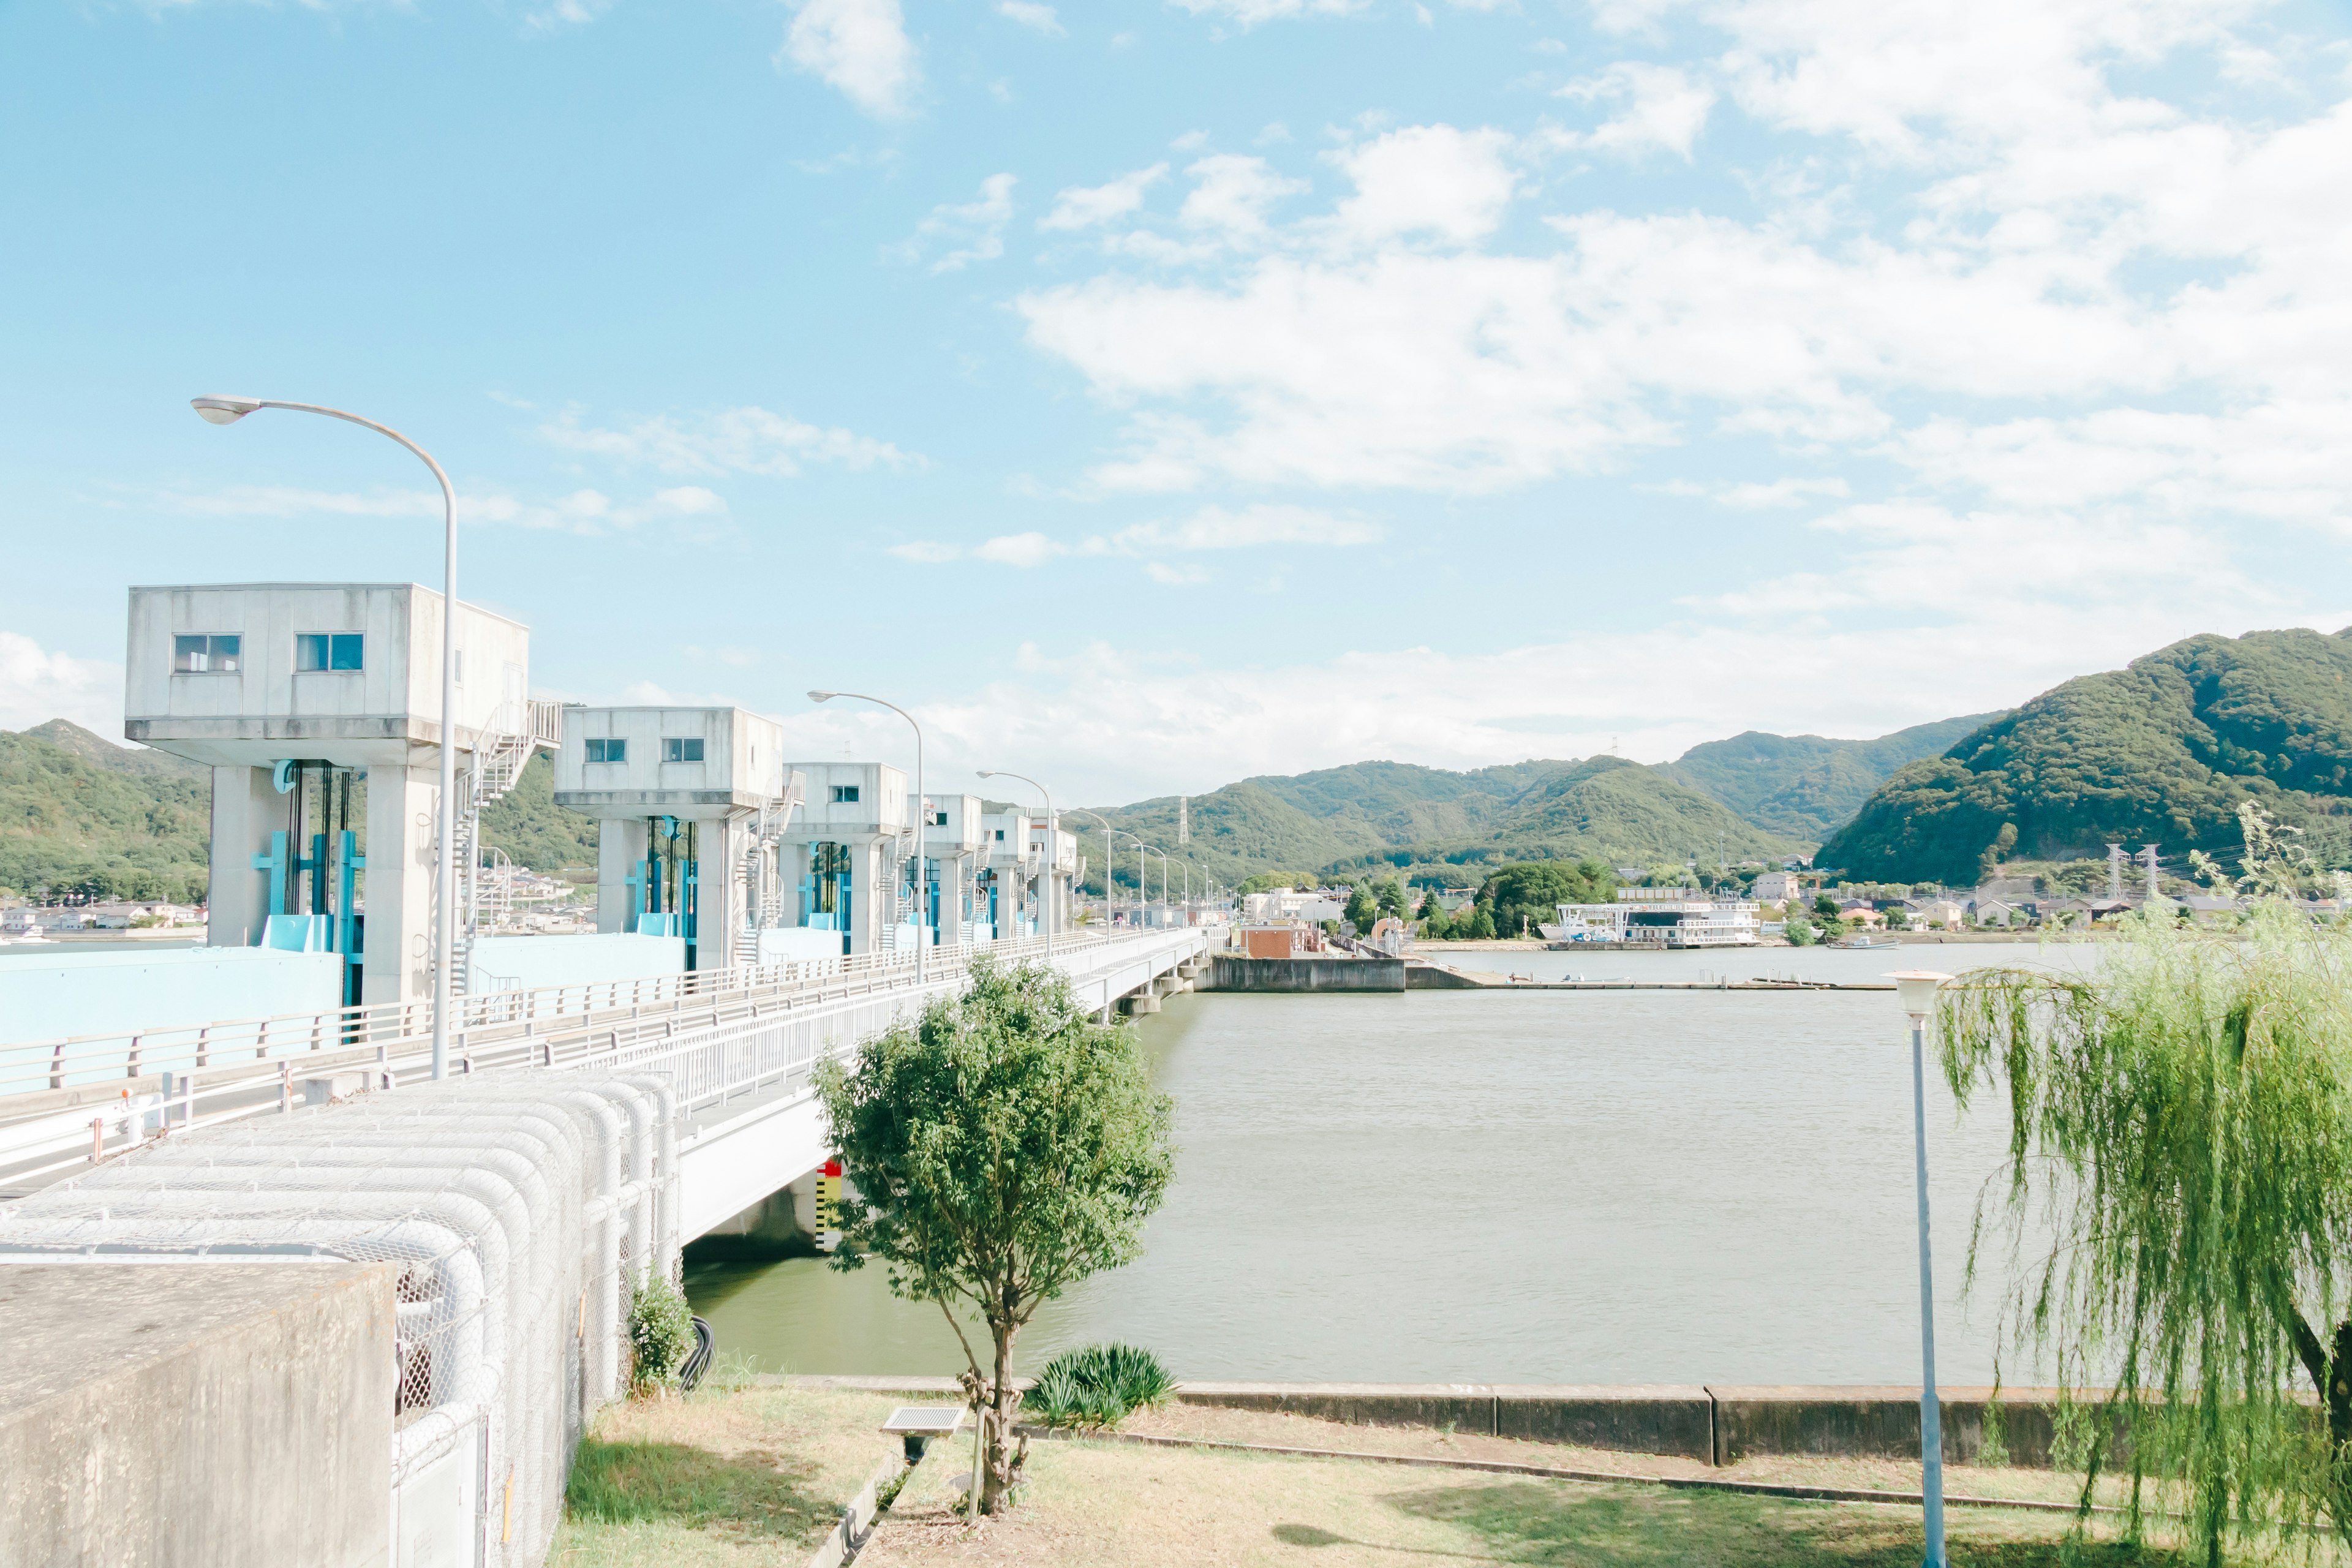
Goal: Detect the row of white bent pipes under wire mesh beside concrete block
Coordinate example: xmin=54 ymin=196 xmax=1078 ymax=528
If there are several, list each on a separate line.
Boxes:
xmin=0 ymin=1069 xmax=677 ymax=1568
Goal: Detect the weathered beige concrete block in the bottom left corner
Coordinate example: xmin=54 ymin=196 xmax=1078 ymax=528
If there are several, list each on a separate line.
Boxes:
xmin=0 ymin=1260 xmax=398 ymax=1568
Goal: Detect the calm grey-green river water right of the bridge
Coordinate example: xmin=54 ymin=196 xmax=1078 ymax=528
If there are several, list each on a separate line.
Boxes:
xmin=687 ymin=945 xmax=2095 ymax=1382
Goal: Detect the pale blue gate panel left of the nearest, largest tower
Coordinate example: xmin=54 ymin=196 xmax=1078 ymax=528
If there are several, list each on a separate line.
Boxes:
xmin=0 ymin=948 xmax=344 ymax=1049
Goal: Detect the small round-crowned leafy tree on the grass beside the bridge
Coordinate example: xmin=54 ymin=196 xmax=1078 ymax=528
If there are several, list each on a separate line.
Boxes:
xmin=816 ymin=964 xmax=1176 ymax=1514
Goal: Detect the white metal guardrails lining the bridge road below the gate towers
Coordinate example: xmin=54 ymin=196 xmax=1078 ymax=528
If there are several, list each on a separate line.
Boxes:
xmin=0 ymin=931 xmax=1197 ymax=1194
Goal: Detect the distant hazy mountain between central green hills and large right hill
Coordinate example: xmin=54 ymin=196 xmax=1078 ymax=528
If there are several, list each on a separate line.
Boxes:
xmin=1665 ymin=712 xmax=2002 ymax=842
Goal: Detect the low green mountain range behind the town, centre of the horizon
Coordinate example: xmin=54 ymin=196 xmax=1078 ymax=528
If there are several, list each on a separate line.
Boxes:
xmin=1072 ymin=757 xmax=1801 ymax=889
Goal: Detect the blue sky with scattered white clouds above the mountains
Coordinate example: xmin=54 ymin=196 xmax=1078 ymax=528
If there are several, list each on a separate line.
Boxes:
xmin=0 ymin=0 xmax=2352 ymax=799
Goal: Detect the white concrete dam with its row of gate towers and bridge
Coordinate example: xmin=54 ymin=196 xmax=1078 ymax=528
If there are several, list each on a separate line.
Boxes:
xmin=0 ymin=586 xmax=1207 ymax=1568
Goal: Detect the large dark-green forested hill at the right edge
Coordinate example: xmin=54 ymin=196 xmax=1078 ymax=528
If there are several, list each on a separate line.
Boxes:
xmin=1815 ymin=630 xmax=2352 ymax=884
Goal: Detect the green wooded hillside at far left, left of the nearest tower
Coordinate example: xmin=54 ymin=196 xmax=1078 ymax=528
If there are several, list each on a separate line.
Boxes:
xmin=0 ymin=719 xmax=212 ymax=903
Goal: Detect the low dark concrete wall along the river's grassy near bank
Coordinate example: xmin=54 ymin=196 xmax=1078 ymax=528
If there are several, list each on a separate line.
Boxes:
xmin=762 ymin=1378 xmax=2058 ymax=1467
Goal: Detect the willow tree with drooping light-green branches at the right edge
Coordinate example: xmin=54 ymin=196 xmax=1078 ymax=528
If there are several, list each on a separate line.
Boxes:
xmin=1938 ymin=886 xmax=2352 ymax=1563
